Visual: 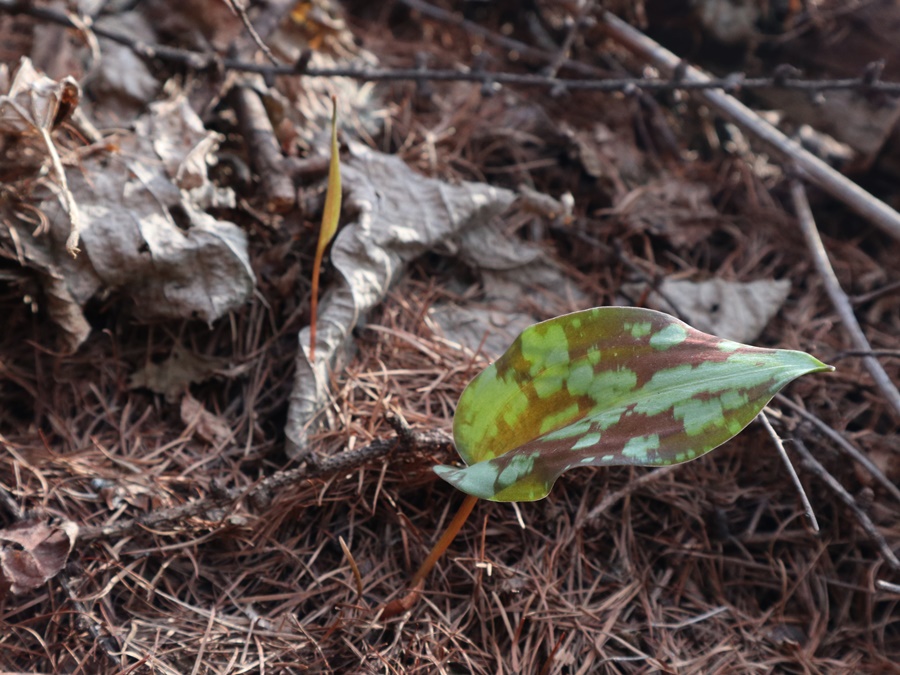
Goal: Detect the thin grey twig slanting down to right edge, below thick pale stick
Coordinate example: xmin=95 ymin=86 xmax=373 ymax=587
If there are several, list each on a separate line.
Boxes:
xmin=791 ymin=178 xmax=900 ymax=418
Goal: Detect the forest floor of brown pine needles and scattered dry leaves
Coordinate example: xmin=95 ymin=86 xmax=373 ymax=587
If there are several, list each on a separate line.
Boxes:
xmin=0 ymin=0 xmax=900 ymax=675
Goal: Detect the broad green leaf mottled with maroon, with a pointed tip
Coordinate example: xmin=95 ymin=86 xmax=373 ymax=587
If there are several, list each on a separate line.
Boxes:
xmin=434 ymin=307 xmax=833 ymax=501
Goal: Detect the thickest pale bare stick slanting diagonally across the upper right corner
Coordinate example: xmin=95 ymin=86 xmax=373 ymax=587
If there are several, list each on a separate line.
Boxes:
xmin=603 ymin=12 xmax=900 ymax=240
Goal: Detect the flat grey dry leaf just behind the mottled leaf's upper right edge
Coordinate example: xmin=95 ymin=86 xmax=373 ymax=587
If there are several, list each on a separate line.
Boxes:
xmin=622 ymin=279 xmax=791 ymax=343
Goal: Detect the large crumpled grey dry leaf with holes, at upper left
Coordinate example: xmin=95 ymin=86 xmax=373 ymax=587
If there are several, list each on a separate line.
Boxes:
xmin=0 ymin=91 xmax=255 ymax=351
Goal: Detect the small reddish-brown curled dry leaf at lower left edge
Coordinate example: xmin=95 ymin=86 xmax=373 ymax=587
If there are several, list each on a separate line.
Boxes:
xmin=0 ymin=520 xmax=78 ymax=599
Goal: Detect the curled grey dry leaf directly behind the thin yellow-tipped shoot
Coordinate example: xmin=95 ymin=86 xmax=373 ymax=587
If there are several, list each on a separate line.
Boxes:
xmin=285 ymin=143 xmax=515 ymax=457
